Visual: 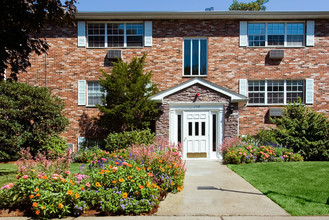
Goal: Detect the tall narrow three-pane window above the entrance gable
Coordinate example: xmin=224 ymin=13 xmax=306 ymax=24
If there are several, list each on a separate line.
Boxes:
xmin=184 ymin=38 xmax=208 ymax=76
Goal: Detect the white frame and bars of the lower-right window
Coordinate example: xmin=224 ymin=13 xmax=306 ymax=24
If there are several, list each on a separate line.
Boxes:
xmin=247 ymin=80 xmax=306 ymax=106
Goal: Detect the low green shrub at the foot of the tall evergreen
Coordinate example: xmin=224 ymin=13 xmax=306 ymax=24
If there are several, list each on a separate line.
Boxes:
xmin=105 ymin=129 xmax=155 ymax=152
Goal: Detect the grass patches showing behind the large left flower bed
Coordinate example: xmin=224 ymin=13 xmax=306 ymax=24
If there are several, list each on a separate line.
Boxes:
xmin=0 ymin=163 xmax=81 ymax=188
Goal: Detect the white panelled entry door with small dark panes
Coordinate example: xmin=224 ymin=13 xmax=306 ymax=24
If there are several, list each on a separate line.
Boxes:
xmin=183 ymin=111 xmax=209 ymax=157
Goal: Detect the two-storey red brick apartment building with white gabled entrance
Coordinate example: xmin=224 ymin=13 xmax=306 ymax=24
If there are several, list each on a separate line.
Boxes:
xmin=20 ymin=11 xmax=329 ymax=158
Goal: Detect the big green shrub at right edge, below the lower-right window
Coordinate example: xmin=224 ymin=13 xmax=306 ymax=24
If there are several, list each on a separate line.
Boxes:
xmin=271 ymin=101 xmax=329 ymax=160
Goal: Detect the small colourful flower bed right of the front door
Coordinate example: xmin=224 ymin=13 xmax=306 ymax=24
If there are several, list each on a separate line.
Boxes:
xmin=224 ymin=143 xmax=303 ymax=164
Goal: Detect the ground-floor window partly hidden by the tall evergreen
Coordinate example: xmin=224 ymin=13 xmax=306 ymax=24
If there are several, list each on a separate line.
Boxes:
xmin=87 ymin=81 xmax=104 ymax=106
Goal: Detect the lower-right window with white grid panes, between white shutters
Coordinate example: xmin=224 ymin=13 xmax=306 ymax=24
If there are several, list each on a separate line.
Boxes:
xmin=248 ymin=80 xmax=305 ymax=105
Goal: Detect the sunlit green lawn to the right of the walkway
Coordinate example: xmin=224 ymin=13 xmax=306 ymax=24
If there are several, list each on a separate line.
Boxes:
xmin=228 ymin=162 xmax=329 ymax=216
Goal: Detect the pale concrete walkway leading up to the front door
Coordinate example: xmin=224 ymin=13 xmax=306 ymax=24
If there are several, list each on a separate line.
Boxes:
xmin=155 ymin=160 xmax=289 ymax=217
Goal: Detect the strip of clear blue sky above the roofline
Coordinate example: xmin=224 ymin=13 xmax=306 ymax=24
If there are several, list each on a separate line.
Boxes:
xmin=77 ymin=0 xmax=329 ymax=12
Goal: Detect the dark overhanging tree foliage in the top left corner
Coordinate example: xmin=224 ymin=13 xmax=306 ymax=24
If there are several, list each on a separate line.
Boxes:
xmin=0 ymin=0 xmax=76 ymax=81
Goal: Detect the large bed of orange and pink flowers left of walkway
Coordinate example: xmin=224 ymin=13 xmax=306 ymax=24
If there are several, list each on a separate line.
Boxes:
xmin=0 ymin=143 xmax=185 ymax=218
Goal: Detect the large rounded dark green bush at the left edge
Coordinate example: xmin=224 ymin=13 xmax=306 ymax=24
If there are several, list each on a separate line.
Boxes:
xmin=0 ymin=81 xmax=69 ymax=160
